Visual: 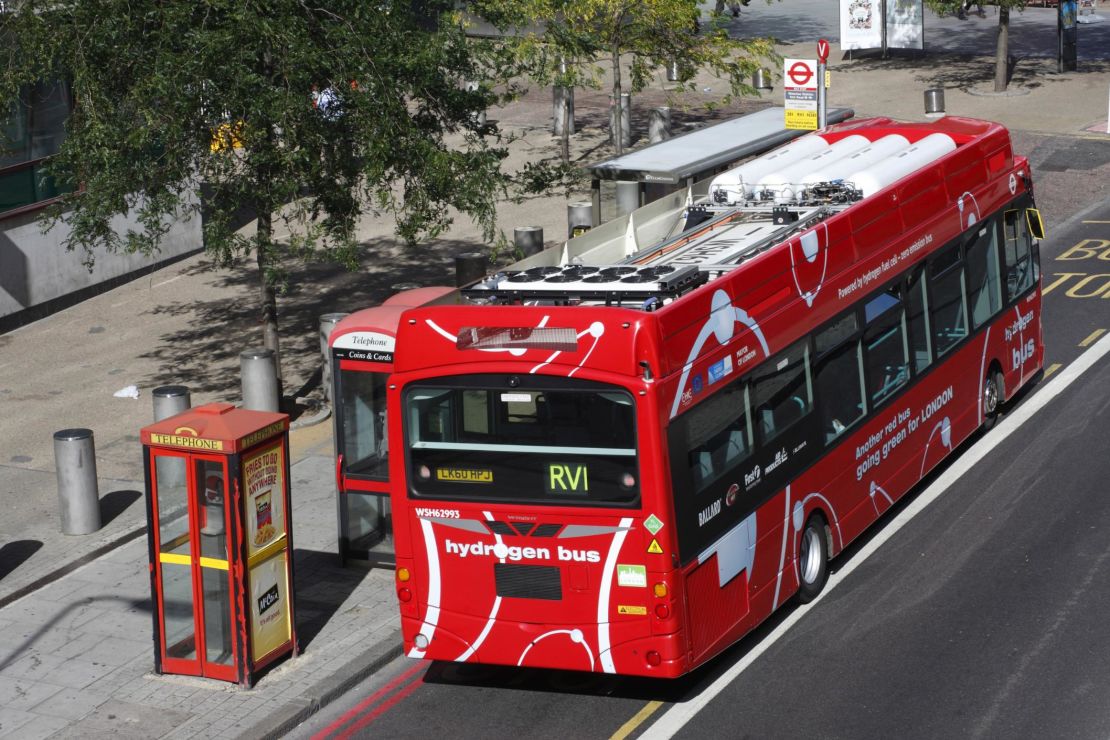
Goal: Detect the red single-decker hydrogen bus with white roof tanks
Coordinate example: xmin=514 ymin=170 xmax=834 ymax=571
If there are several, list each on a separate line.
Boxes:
xmin=387 ymin=116 xmax=1043 ymax=677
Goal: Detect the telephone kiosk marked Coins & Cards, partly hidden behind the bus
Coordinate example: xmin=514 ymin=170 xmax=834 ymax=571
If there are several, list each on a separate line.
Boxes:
xmin=327 ymin=286 xmax=455 ymax=565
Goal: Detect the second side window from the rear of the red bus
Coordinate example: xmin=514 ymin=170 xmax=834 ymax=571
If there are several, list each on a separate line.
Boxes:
xmin=751 ymin=339 xmax=814 ymax=443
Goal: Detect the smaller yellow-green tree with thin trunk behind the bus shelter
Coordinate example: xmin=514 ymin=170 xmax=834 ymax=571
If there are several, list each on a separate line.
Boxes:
xmin=471 ymin=0 xmax=775 ymax=154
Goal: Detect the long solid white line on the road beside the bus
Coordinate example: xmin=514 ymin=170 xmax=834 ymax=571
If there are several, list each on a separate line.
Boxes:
xmin=640 ymin=334 xmax=1110 ymax=740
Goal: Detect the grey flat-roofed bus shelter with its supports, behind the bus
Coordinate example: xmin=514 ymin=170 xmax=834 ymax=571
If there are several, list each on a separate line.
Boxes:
xmin=586 ymin=107 xmax=855 ymax=226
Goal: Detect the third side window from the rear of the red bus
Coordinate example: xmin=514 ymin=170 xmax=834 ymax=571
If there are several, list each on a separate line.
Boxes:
xmin=814 ymin=311 xmax=867 ymax=442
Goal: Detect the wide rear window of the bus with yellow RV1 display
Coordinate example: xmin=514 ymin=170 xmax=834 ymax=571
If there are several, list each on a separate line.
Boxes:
xmin=404 ymin=376 xmax=639 ymax=505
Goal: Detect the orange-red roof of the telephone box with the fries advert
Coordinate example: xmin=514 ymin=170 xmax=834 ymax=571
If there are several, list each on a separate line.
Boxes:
xmin=140 ymin=404 xmax=289 ymax=455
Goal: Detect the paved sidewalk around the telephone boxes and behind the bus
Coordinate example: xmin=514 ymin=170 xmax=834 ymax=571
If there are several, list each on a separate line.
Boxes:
xmin=0 ymin=5 xmax=1110 ymax=739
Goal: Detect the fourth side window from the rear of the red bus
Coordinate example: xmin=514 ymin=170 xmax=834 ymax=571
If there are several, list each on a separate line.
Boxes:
xmin=864 ymin=285 xmax=909 ymax=405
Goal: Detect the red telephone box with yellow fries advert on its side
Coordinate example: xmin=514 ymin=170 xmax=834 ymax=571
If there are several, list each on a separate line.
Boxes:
xmin=142 ymin=404 xmax=297 ymax=687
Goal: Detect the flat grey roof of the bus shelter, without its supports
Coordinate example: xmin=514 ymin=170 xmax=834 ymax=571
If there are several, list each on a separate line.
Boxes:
xmin=586 ymin=107 xmax=855 ymax=183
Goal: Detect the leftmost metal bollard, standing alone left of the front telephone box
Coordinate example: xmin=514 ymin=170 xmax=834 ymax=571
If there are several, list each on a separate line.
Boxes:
xmin=54 ymin=429 xmax=100 ymax=535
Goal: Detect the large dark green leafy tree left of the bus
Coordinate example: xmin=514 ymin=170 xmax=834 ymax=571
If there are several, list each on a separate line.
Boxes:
xmin=0 ymin=0 xmax=512 ymax=388
